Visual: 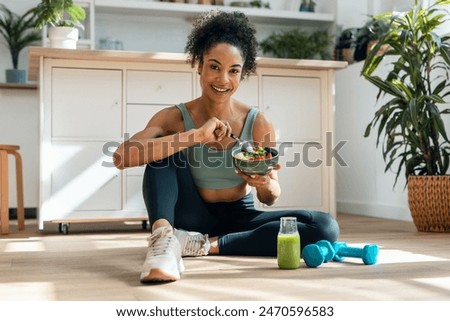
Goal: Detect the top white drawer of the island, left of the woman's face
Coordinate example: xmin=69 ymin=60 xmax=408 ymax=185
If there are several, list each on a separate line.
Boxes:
xmin=127 ymin=70 xmax=193 ymax=105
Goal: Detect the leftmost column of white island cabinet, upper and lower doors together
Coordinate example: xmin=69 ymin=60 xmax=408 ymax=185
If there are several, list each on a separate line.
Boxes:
xmin=40 ymin=62 xmax=122 ymax=228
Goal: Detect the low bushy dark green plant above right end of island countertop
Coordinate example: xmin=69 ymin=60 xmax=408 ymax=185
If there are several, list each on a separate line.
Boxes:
xmin=260 ymin=29 xmax=332 ymax=59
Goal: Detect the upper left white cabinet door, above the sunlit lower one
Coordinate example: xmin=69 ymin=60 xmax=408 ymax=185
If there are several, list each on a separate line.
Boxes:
xmin=51 ymin=67 xmax=122 ymax=139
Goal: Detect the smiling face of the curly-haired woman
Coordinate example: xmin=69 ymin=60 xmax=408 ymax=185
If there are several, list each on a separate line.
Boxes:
xmin=198 ymin=43 xmax=244 ymax=101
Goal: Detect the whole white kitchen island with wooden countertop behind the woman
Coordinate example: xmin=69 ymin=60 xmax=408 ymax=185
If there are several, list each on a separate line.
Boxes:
xmin=29 ymin=47 xmax=346 ymax=229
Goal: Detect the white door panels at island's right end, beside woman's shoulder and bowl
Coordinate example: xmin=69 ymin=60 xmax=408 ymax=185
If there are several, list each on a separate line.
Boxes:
xmin=262 ymin=76 xmax=325 ymax=209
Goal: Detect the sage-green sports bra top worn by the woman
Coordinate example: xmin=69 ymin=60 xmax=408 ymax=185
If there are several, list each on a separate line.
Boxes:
xmin=176 ymin=103 xmax=258 ymax=189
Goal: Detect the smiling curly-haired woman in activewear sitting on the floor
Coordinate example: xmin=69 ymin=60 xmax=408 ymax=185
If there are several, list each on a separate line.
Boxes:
xmin=114 ymin=11 xmax=339 ymax=283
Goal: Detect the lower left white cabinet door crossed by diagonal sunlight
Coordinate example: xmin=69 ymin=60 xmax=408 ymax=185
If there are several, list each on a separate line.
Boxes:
xmin=45 ymin=142 xmax=122 ymax=218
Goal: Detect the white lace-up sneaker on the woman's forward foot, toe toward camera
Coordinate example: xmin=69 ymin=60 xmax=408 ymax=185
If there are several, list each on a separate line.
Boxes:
xmin=141 ymin=226 xmax=184 ymax=283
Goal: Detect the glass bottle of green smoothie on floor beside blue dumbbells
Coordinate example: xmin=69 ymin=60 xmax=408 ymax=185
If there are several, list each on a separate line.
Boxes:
xmin=277 ymin=217 xmax=300 ymax=269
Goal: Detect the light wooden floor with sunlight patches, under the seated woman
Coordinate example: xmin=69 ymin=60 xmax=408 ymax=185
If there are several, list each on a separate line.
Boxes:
xmin=0 ymin=214 xmax=450 ymax=301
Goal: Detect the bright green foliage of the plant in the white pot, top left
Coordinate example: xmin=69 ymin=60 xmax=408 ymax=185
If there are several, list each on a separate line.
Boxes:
xmin=34 ymin=0 xmax=86 ymax=28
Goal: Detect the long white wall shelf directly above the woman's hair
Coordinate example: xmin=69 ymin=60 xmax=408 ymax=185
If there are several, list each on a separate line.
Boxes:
xmin=95 ymin=0 xmax=335 ymax=24
